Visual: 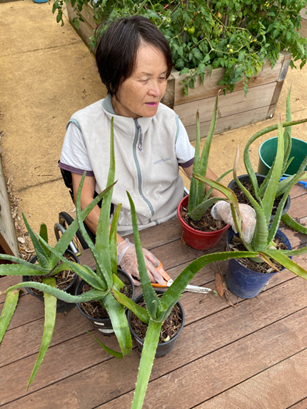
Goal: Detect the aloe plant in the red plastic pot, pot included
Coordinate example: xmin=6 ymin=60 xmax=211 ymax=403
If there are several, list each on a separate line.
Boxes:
xmin=177 ymin=96 xmax=231 ymax=250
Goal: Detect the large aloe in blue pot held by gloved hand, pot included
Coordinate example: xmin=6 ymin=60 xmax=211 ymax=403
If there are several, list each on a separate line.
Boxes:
xmin=194 ymin=113 xmax=307 ymax=298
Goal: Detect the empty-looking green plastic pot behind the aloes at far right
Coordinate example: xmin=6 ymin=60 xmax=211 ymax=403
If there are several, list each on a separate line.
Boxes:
xmin=257 ymin=136 xmax=307 ymax=177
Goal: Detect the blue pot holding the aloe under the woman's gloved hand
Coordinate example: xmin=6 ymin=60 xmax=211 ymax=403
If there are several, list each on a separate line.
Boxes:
xmin=226 ymin=229 xmax=292 ymax=298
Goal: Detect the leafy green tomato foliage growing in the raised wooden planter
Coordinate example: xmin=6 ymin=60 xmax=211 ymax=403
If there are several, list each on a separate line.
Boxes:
xmin=53 ymin=0 xmax=307 ymax=95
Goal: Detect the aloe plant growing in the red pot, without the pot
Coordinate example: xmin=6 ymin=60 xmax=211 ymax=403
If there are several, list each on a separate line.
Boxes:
xmin=188 ymin=96 xmax=231 ymax=221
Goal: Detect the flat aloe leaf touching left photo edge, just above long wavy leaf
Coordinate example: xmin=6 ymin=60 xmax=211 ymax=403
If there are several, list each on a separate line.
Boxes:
xmin=0 ymin=260 xmax=50 ymax=276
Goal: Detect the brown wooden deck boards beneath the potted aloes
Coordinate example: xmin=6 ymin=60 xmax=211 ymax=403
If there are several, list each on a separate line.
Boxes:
xmin=0 ymin=186 xmax=307 ymax=409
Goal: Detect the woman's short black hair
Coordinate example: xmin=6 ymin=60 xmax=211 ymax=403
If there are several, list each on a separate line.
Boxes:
xmin=96 ymin=16 xmax=173 ymax=96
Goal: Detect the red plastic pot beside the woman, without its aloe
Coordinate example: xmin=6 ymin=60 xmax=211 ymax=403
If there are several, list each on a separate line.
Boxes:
xmin=177 ymin=196 xmax=230 ymax=250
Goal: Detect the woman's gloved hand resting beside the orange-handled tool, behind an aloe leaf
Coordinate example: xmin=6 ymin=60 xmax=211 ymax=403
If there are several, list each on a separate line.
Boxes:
xmin=117 ymin=239 xmax=164 ymax=285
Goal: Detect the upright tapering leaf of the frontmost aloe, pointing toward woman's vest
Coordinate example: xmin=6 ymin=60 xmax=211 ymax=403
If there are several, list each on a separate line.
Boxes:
xmin=127 ymin=192 xmax=160 ymax=320
